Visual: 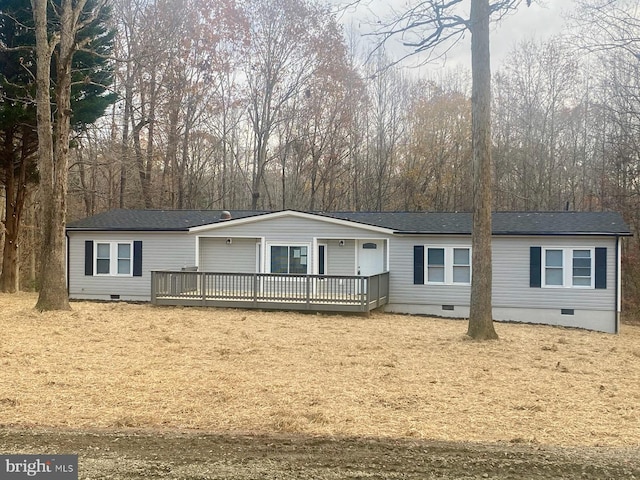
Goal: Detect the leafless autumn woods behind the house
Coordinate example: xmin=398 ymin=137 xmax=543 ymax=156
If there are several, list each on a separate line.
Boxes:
xmin=0 ymin=0 xmax=640 ymax=313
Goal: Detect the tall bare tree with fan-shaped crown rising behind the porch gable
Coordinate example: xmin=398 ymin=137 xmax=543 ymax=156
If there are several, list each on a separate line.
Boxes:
xmin=245 ymin=0 xmax=338 ymax=209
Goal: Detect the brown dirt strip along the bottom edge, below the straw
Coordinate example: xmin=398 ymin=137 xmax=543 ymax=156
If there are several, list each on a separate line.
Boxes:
xmin=0 ymin=429 xmax=640 ymax=480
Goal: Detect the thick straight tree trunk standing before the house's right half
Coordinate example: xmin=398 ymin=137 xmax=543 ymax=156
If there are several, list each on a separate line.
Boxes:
xmin=467 ymin=0 xmax=498 ymax=340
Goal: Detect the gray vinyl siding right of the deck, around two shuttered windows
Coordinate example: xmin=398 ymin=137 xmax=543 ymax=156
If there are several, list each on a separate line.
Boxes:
xmin=389 ymin=236 xmax=616 ymax=312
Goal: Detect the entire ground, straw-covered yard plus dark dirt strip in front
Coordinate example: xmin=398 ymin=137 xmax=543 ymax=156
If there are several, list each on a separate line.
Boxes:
xmin=0 ymin=294 xmax=640 ymax=480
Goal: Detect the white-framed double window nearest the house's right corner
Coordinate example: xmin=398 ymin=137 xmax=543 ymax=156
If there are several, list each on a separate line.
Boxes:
xmin=543 ymin=248 xmax=595 ymax=288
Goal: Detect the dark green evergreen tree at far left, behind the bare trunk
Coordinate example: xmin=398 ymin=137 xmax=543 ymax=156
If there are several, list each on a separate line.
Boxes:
xmin=0 ymin=0 xmax=115 ymax=292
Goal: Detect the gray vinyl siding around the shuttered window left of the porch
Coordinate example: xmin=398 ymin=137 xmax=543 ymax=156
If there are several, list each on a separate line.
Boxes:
xmin=68 ymin=232 xmax=195 ymax=301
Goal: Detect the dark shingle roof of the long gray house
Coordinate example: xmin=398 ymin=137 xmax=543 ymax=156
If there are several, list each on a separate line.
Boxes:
xmin=67 ymin=210 xmax=630 ymax=235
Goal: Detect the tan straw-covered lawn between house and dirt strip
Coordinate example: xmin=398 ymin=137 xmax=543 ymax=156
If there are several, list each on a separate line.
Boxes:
xmin=0 ymin=294 xmax=640 ymax=446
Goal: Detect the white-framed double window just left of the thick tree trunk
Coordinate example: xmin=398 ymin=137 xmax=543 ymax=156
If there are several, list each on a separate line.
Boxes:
xmin=426 ymin=247 xmax=471 ymax=285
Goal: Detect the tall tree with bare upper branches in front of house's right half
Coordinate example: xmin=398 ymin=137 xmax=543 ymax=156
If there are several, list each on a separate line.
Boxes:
xmin=368 ymin=0 xmax=531 ymax=340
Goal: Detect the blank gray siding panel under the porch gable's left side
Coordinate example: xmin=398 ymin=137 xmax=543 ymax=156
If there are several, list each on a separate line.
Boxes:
xmin=198 ymin=237 xmax=257 ymax=273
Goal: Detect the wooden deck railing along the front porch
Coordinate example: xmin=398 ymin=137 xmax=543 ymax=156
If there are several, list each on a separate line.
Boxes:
xmin=151 ymin=269 xmax=389 ymax=312
